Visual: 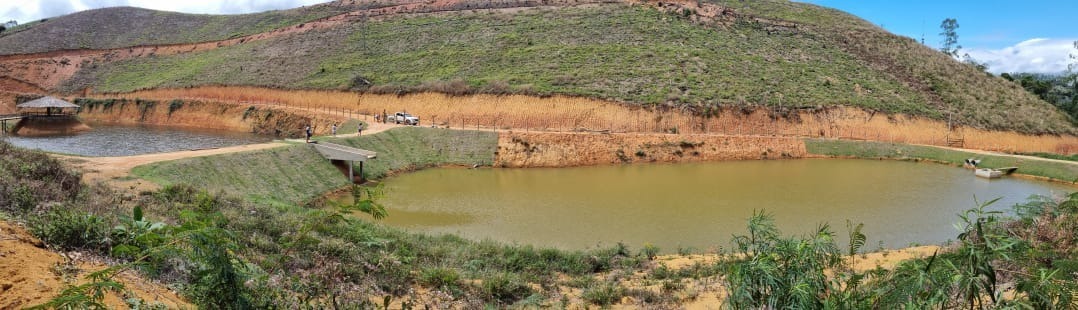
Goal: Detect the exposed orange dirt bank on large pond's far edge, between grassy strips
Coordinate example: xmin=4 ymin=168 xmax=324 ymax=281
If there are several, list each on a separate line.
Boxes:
xmin=495 ymin=132 xmax=806 ymax=167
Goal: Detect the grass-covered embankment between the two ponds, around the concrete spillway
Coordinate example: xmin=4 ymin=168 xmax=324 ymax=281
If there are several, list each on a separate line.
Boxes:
xmin=133 ymin=127 xmax=498 ymax=205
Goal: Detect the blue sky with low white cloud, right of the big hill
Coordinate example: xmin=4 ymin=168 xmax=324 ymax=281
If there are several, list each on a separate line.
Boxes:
xmin=803 ymin=0 xmax=1078 ymax=73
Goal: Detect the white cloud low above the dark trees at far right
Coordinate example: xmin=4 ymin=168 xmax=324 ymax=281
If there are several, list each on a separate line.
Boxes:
xmin=959 ymin=38 xmax=1078 ymax=73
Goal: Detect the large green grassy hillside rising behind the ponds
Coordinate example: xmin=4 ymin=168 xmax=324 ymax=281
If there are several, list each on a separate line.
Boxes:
xmin=0 ymin=0 xmax=1078 ymax=133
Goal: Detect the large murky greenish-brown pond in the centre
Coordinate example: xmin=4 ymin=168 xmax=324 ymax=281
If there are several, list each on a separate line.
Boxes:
xmin=340 ymin=159 xmax=1074 ymax=252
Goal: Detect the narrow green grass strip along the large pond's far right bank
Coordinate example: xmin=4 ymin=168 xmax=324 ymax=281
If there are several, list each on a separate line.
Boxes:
xmin=805 ymin=139 xmax=1078 ymax=182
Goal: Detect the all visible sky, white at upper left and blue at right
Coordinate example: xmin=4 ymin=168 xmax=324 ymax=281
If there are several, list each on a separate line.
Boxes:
xmin=0 ymin=0 xmax=1078 ymax=73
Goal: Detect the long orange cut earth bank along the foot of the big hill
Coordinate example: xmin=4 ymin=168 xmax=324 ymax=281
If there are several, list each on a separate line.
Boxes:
xmin=109 ymin=86 xmax=1078 ymax=154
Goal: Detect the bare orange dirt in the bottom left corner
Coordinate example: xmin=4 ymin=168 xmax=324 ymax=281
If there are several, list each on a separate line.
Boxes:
xmin=0 ymin=221 xmax=194 ymax=309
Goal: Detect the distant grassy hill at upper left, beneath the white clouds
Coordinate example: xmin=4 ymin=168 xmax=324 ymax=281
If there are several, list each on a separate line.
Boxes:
xmin=0 ymin=3 xmax=357 ymax=55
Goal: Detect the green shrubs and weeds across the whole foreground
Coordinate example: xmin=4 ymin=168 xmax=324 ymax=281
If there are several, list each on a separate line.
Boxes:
xmin=6 ymin=137 xmax=1078 ymax=309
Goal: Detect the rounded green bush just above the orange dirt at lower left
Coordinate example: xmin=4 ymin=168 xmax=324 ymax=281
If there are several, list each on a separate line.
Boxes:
xmin=29 ymin=207 xmax=111 ymax=251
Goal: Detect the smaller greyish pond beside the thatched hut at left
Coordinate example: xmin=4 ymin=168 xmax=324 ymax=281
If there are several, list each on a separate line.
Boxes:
xmin=4 ymin=124 xmax=273 ymax=156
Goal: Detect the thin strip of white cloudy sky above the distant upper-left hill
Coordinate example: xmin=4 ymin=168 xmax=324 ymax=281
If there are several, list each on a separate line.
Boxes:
xmin=0 ymin=0 xmax=329 ymax=24
